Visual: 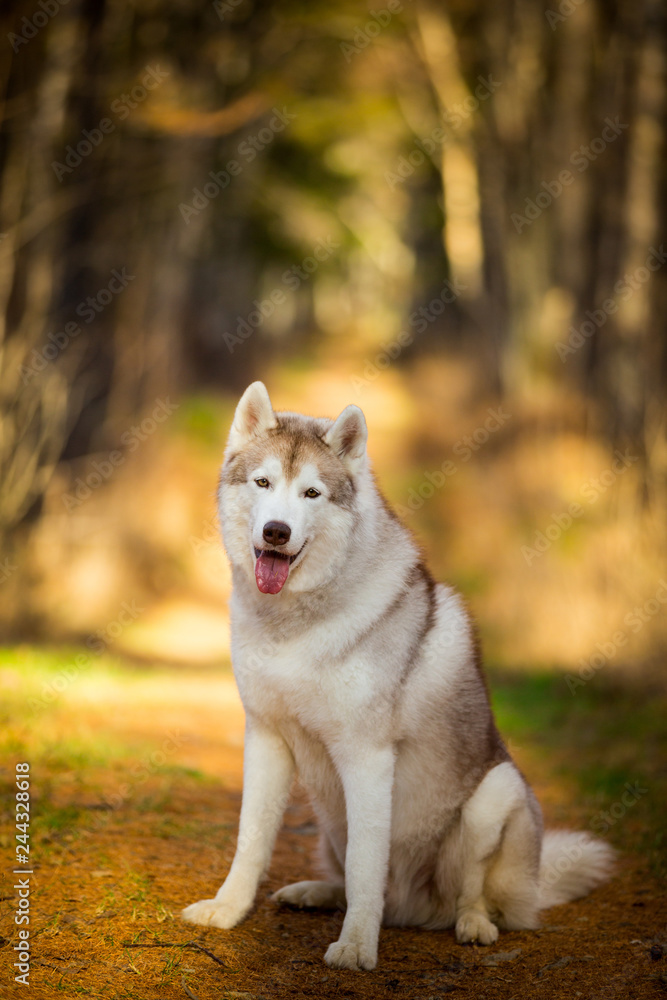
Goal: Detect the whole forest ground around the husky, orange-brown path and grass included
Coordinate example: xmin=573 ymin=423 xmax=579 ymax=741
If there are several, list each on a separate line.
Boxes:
xmin=0 ymin=647 xmax=667 ymax=1000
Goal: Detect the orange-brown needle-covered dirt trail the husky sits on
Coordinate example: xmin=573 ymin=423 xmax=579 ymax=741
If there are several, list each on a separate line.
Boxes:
xmin=0 ymin=672 xmax=667 ymax=1000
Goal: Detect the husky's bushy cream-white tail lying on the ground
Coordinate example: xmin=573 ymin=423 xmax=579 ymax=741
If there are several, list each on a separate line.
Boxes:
xmin=539 ymin=830 xmax=614 ymax=909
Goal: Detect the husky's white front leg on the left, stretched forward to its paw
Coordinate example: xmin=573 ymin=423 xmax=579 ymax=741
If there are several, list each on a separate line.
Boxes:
xmin=182 ymin=719 xmax=294 ymax=929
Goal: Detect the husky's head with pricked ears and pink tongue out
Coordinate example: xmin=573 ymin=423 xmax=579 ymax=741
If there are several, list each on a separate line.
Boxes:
xmin=219 ymin=382 xmax=368 ymax=594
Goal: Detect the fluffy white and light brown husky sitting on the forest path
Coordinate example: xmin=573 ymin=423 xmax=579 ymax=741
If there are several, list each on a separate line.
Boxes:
xmin=183 ymin=382 xmax=613 ymax=970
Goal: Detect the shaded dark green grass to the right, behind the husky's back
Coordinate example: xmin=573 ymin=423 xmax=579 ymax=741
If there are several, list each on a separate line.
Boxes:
xmin=489 ymin=671 xmax=667 ymax=875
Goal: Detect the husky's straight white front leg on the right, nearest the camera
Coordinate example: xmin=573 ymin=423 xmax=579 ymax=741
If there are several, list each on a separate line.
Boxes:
xmin=324 ymin=745 xmax=394 ymax=969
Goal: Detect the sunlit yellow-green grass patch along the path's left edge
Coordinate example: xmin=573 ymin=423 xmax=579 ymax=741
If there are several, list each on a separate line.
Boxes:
xmin=0 ymin=646 xmax=229 ymax=872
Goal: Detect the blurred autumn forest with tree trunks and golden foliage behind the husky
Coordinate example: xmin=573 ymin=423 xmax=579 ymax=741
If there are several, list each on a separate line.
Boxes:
xmin=0 ymin=0 xmax=667 ymax=677
